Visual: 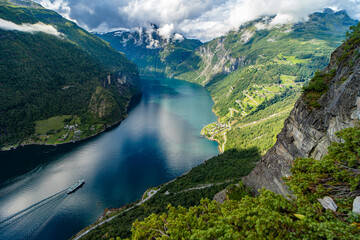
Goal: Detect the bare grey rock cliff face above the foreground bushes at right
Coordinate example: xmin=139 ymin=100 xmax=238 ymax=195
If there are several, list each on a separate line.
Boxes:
xmin=243 ymin=39 xmax=360 ymax=195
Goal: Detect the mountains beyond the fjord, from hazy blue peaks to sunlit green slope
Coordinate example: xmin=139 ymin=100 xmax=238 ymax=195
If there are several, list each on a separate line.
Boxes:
xmin=98 ymin=9 xmax=357 ymax=157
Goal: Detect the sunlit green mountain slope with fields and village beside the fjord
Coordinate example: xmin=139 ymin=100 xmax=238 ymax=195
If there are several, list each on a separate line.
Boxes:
xmin=180 ymin=9 xmax=356 ymax=153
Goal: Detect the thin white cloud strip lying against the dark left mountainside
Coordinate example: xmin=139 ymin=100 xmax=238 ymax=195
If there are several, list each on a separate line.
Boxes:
xmin=0 ymin=18 xmax=63 ymax=37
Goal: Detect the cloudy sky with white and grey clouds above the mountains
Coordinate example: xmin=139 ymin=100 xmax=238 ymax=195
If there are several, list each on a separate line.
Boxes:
xmin=35 ymin=0 xmax=360 ymax=41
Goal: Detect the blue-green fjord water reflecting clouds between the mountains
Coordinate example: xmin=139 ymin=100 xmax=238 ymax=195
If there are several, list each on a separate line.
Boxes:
xmin=0 ymin=79 xmax=218 ymax=240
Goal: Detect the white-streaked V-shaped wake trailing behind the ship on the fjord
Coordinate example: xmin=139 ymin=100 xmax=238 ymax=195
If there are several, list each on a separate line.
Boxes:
xmin=0 ymin=189 xmax=68 ymax=240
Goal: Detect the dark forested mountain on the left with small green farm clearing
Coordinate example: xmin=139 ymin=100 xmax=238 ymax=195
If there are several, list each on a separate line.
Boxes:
xmin=0 ymin=0 xmax=141 ymax=149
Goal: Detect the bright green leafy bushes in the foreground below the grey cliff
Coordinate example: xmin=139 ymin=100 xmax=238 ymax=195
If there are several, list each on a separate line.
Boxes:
xmin=125 ymin=127 xmax=360 ymax=239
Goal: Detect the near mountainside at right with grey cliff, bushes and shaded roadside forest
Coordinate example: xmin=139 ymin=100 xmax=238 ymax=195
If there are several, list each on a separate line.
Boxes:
xmin=72 ymin=19 xmax=360 ymax=239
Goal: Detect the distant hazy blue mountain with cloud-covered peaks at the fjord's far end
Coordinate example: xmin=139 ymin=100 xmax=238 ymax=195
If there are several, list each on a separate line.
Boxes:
xmin=96 ymin=24 xmax=202 ymax=76
